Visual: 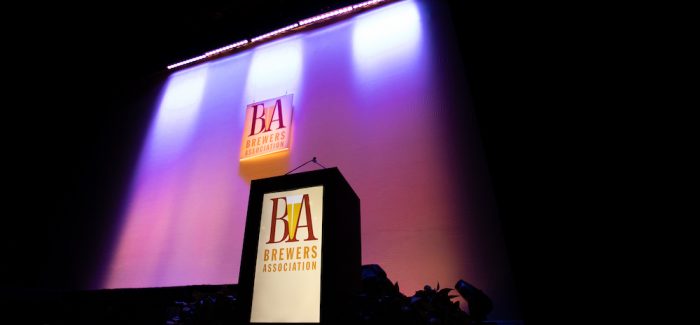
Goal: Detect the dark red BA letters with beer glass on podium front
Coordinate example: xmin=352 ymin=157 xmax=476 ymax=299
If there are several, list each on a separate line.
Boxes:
xmin=266 ymin=194 xmax=318 ymax=244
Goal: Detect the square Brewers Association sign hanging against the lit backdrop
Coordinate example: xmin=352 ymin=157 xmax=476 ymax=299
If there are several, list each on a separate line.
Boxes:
xmin=240 ymin=94 xmax=292 ymax=160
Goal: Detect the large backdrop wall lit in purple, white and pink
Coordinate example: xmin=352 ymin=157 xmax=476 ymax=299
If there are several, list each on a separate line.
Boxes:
xmin=103 ymin=1 xmax=516 ymax=318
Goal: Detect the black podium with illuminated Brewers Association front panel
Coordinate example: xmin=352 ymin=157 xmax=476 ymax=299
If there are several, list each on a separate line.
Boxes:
xmin=238 ymin=168 xmax=362 ymax=324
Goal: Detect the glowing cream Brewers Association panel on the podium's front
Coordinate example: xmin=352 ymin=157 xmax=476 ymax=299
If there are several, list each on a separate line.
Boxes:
xmin=250 ymin=186 xmax=323 ymax=323
